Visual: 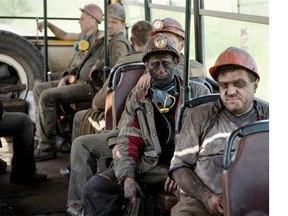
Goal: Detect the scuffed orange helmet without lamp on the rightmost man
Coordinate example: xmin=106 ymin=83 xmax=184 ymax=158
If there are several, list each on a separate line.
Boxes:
xmin=209 ymin=47 xmax=260 ymax=81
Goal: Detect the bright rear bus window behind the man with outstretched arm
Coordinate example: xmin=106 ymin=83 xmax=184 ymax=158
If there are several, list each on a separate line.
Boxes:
xmin=0 ymin=0 xmax=104 ymax=37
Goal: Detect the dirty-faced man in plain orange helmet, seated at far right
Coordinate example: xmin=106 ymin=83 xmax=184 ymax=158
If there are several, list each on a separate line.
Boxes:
xmin=169 ymin=47 xmax=269 ymax=216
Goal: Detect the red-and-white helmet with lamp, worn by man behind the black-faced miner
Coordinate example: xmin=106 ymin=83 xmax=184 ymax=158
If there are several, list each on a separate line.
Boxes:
xmin=151 ymin=18 xmax=185 ymax=40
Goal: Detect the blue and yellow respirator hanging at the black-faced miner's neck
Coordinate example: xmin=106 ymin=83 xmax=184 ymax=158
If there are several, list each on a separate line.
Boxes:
xmin=150 ymin=79 xmax=178 ymax=113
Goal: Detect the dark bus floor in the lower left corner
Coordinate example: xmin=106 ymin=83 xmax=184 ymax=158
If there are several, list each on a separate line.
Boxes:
xmin=0 ymin=138 xmax=69 ymax=216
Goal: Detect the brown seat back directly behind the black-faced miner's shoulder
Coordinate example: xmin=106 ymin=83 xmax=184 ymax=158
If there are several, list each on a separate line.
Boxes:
xmin=105 ymin=62 xmax=146 ymax=130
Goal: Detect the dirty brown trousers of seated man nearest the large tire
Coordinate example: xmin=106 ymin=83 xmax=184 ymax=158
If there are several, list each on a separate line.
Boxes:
xmin=33 ymin=80 xmax=95 ymax=151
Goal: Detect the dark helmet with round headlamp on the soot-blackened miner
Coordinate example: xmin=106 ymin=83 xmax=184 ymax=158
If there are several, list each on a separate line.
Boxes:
xmin=142 ymin=33 xmax=179 ymax=62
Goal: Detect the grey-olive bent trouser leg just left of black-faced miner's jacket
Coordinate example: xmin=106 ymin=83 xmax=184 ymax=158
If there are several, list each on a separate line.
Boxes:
xmin=67 ymin=131 xmax=112 ymax=206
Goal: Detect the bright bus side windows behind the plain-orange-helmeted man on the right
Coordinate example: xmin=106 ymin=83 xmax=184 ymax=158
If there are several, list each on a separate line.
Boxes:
xmin=122 ymin=0 xmax=269 ymax=101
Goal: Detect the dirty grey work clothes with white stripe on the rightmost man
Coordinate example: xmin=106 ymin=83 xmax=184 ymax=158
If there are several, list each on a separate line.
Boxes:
xmin=169 ymin=101 xmax=269 ymax=216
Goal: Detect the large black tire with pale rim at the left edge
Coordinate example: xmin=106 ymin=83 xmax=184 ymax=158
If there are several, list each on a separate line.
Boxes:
xmin=0 ymin=30 xmax=44 ymax=99
